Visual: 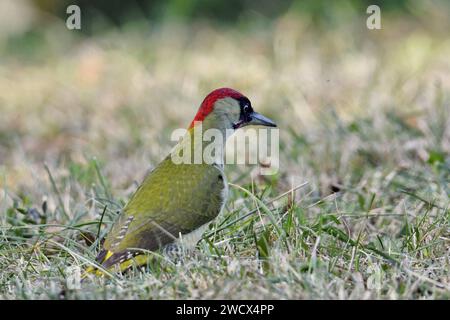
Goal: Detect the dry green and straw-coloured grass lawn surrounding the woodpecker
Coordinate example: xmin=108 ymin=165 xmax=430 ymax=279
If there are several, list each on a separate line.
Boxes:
xmin=0 ymin=4 xmax=450 ymax=299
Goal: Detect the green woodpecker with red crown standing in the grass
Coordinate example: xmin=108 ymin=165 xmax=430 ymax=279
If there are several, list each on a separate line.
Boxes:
xmin=88 ymin=88 xmax=276 ymax=272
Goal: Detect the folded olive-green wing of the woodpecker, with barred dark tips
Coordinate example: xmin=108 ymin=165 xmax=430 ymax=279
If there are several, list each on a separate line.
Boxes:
xmin=97 ymin=158 xmax=226 ymax=267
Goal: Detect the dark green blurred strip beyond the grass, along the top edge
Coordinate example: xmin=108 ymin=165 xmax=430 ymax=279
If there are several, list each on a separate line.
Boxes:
xmin=29 ymin=0 xmax=442 ymax=25
